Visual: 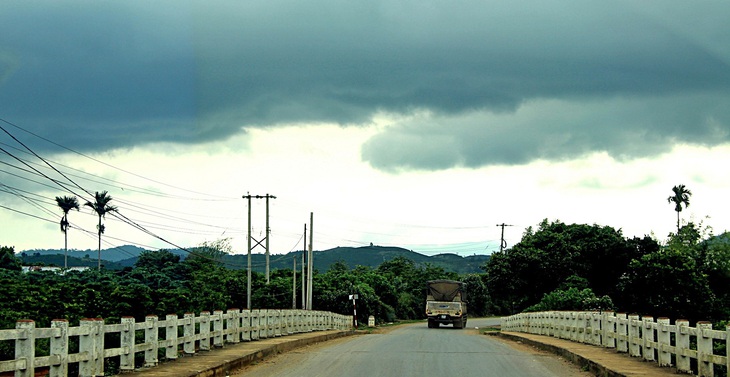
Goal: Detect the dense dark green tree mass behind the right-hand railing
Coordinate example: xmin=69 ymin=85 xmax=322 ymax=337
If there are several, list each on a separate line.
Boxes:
xmin=485 ymin=220 xmax=730 ymax=321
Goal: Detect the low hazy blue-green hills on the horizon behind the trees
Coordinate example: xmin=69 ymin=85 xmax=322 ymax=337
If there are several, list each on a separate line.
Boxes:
xmin=18 ymin=246 xmax=489 ymax=274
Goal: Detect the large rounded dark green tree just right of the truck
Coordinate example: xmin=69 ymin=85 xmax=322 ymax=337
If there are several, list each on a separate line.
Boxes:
xmin=485 ymin=220 xmax=652 ymax=314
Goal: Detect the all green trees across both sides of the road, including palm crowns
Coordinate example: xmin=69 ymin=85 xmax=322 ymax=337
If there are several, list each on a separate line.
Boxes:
xmin=5 ymin=185 xmax=730 ymax=357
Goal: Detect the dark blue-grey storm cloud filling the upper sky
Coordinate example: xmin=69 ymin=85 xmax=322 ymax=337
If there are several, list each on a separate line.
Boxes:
xmin=0 ymin=0 xmax=730 ymax=169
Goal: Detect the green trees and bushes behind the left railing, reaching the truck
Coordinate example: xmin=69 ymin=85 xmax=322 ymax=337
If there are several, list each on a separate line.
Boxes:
xmin=0 ymin=244 xmax=488 ymax=359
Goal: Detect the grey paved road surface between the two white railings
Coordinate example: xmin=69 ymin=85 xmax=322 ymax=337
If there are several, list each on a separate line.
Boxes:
xmin=231 ymin=319 xmax=590 ymax=377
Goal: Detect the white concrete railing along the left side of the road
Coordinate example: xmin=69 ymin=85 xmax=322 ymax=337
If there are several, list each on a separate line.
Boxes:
xmin=0 ymin=309 xmax=353 ymax=377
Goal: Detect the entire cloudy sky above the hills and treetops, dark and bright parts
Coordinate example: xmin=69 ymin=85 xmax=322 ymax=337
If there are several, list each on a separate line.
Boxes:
xmin=0 ymin=0 xmax=730 ymax=256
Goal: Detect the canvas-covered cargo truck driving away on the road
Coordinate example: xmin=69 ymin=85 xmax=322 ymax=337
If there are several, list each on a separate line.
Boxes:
xmin=426 ymin=280 xmax=467 ymax=329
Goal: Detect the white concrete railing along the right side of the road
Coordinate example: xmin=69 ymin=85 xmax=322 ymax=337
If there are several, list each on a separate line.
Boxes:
xmin=502 ymin=312 xmax=730 ymax=377
